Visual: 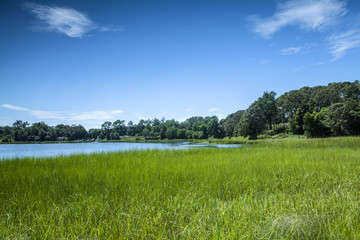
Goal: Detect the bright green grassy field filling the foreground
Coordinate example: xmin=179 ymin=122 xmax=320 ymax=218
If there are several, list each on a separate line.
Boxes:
xmin=0 ymin=138 xmax=360 ymax=239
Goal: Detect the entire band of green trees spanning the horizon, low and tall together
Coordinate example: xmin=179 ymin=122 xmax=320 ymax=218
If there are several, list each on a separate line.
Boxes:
xmin=0 ymin=81 xmax=360 ymax=142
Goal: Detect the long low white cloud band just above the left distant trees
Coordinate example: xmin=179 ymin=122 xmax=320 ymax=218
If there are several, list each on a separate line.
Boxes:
xmin=1 ymin=104 xmax=123 ymax=121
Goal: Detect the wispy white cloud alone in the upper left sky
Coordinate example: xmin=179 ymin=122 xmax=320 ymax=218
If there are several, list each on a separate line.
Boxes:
xmin=23 ymin=2 xmax=122 ymax=38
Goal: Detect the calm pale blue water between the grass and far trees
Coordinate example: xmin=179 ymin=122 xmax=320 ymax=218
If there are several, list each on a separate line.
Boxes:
xmin=0 ymin=142 xmax=239 ymax=160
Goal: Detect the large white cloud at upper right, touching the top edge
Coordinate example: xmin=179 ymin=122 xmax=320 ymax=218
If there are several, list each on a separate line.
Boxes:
xmin=249 ymin=0 xmax=347 ymax=38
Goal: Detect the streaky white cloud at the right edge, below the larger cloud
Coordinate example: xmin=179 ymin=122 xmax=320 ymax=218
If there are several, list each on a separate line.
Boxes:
xmin=328 ymin=29 xmax=360 ymax=61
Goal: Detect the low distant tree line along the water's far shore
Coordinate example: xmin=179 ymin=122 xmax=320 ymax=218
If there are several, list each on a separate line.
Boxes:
xmin=0 ymin=116 xmax=225 ymax=142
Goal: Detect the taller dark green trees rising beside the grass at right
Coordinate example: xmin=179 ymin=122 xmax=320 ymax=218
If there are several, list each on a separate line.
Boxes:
xmin=231 ymin=80 xmax=360 ymax=138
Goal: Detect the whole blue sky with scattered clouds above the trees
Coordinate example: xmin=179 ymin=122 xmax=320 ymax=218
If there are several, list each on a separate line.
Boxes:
xmin=0 ymin=0 xmax=360 ymax=128
